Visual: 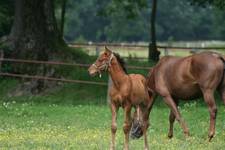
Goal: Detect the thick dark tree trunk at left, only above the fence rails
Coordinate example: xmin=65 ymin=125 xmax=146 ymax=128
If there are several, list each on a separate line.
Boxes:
xmin=9 ymin=0 xmax=65 ymax=60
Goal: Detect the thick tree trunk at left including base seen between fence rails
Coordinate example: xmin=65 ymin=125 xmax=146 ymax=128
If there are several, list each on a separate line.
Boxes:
xmin=8 ymin=0 xmax=66 ymax=93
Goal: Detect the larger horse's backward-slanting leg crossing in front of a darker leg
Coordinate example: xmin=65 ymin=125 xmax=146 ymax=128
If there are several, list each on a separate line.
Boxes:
xmin=164 ymin=95 xmax=189 ymax=136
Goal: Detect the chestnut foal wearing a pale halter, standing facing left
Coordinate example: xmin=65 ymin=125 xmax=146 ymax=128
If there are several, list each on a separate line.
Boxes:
xmin=88 ymin=47 xmax=152 ymax=150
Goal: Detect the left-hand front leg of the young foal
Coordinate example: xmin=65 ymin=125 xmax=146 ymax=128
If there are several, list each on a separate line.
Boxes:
xmin=110 ymin=103 xmax=118 ymax=150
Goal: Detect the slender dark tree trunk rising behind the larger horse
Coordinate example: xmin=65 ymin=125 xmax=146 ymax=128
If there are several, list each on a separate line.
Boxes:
xmin=148 ymin=0 xmax=160 ymax=61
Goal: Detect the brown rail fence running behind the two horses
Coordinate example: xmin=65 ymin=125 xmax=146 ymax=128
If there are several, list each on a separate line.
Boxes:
xmin=0 ymin=43 xmax=225 ymax=86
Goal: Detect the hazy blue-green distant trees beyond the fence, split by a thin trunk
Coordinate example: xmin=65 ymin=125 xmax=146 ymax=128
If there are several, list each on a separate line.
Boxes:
xmin=65 ymin=0 xmax=225 ymax=42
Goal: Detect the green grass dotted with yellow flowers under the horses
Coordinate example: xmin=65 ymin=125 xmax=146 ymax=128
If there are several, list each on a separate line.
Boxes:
xmin=0 ymin=80 xmax=225 ymax=150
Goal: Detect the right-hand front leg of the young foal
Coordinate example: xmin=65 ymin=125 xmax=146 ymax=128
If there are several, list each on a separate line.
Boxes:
xmin=123 ymin=104 xmax=131 ymax=150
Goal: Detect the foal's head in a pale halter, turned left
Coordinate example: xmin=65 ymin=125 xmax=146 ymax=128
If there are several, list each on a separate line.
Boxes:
xmin=88 ymin=46 xmax=113 ymax=77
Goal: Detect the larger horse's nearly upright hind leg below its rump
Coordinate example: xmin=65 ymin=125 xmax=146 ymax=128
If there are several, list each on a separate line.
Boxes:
xmin=203 ymin=89 xmax=217 ymax=141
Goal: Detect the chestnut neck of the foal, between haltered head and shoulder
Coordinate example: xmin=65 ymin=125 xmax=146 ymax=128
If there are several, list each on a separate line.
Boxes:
xmin=109 ymin=58 xmax=128 ymax=88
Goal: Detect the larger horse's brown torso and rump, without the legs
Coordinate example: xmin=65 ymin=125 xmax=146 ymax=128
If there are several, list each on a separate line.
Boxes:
xmin=153 ymin=52 xmax=223 ymax=99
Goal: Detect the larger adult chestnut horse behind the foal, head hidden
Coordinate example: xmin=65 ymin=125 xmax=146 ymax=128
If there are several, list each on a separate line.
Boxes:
xmin=132 ymin=52 xmax=225 ymax=141
